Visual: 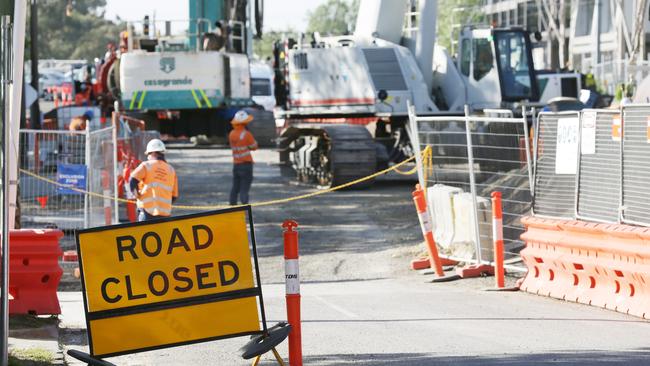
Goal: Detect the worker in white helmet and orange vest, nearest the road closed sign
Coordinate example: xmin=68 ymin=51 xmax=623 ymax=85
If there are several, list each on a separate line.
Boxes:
xmin=129 ymin=139 xmax=178 ymax=221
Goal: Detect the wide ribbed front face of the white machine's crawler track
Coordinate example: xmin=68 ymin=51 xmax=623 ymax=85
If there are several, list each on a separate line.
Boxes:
xmin=323 ymin=125 xmax=377 ymax=188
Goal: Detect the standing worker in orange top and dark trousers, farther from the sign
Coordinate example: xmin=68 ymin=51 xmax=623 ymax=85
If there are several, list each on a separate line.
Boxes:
xmin=228 ymin=111 xmax=257 ymax=205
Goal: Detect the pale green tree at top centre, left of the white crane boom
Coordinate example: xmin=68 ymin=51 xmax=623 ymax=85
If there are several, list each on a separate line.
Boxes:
xmin=307 ymin=0 xmax=359 ymax=36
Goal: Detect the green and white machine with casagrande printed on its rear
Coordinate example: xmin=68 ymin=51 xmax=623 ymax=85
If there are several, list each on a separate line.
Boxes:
xmin=110 ymin=0 xmax=261 ymax=138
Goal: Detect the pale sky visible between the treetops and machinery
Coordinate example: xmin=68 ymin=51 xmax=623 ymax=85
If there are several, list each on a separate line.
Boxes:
xmin=105 ymin=0 xmax=326 ymax=31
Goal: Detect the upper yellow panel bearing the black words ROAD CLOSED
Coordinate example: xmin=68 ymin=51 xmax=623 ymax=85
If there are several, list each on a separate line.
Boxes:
xmin=80 ymin=212 xmax=254 ymax=310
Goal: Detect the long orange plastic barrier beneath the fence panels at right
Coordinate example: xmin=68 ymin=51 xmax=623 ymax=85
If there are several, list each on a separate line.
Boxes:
xmin=521 ymin=217 xmax=650 ymax=318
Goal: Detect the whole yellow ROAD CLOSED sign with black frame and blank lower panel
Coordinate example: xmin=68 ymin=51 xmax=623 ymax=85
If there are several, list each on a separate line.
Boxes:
xmin=77 ymin=207 xmax=266 ymax=357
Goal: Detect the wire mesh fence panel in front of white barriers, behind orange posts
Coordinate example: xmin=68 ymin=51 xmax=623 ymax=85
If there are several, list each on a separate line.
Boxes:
xmin=416 ymin=113 xmax=532 ymax=261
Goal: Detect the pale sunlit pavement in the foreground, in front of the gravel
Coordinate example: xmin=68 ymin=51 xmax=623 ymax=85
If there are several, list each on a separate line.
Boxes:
xmin=59 ymin=274 xmax=650 ymax=365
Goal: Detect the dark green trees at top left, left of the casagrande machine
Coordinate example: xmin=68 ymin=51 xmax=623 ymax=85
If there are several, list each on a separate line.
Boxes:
xmin=32 ymin=0 xmax=126 ymax=61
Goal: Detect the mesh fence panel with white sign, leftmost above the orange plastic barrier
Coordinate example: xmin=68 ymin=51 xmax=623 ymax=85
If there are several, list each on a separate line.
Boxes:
xmin=533 ymin=112 xmax=580 ymax=219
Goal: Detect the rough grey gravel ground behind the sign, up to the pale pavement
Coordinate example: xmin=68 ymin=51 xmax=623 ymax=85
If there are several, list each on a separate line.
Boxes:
xmin=59 ymin=148 xmax=425 ymax=291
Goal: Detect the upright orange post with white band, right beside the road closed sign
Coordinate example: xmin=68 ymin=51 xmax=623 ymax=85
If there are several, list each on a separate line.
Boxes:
xmin=282 ymin=220 xmax=302 ymax=366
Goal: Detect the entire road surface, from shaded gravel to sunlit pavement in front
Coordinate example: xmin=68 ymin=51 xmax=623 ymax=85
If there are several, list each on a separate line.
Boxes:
xmin=61 ymin=149 xmax=650 ymax=365
